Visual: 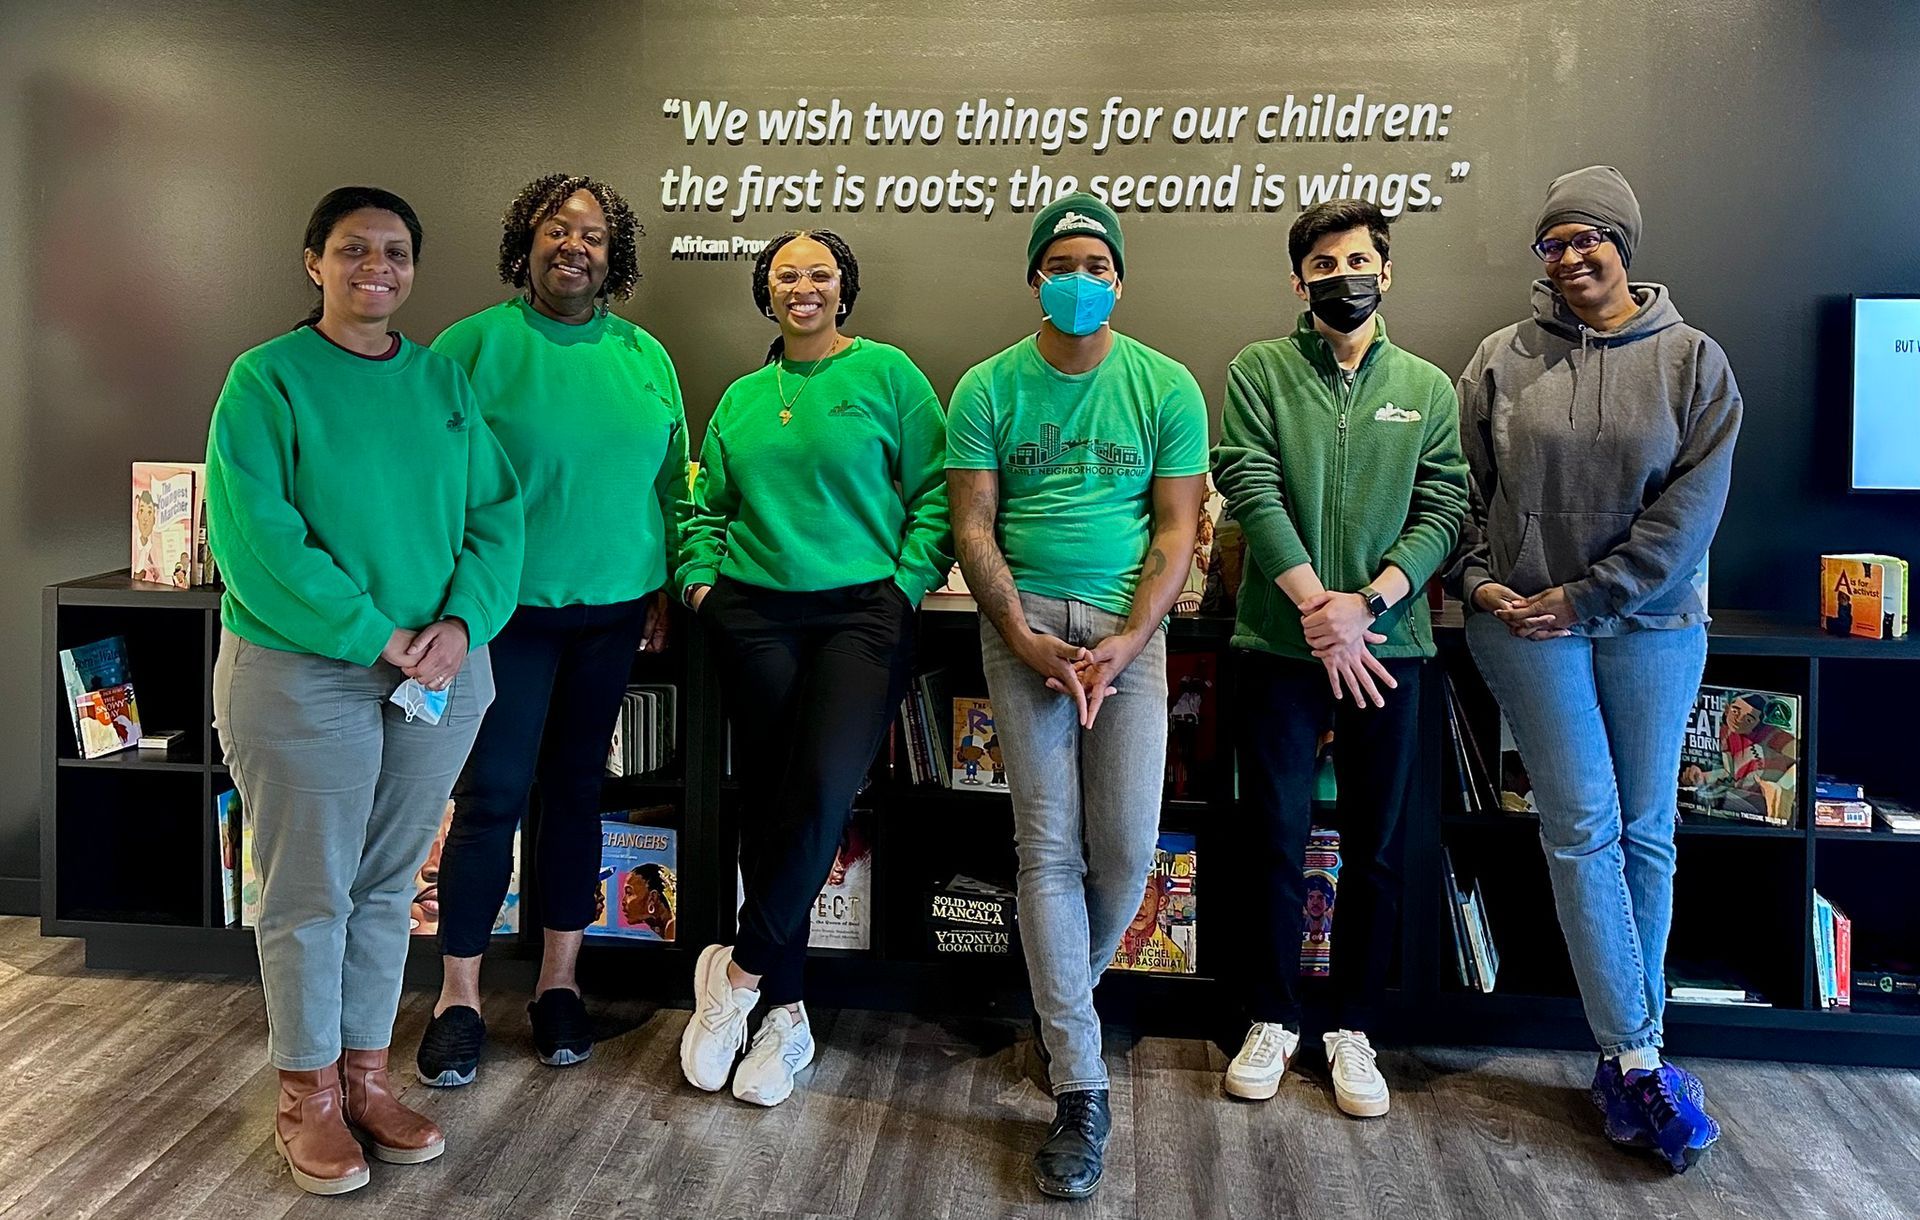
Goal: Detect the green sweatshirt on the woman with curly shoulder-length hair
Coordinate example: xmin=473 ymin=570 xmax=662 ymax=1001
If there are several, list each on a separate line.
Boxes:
xmin=434 ymin=298 xmax=691 ymax=605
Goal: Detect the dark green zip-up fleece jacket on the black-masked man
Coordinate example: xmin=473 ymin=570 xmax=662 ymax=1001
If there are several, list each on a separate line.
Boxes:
xmin=1213 ymin=313 xmax=1467 ymax=657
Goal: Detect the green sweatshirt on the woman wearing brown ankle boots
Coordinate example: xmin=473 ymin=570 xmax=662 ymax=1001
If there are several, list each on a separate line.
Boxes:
xmin=207 ymin=327 xmax=524 ymax=665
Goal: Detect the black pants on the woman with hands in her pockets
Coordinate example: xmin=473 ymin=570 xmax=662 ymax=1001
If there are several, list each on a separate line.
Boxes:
xmin=701 ymin=576 xmax=914 ymax=1005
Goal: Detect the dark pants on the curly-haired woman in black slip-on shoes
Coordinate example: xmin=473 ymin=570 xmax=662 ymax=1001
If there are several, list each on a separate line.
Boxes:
xmin=440 ymin=598 xmax=649 ymax=957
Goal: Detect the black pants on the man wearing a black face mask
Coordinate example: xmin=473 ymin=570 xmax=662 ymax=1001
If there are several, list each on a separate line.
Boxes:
xmin=1227 ymin=649 xmax=1421 ymax=1030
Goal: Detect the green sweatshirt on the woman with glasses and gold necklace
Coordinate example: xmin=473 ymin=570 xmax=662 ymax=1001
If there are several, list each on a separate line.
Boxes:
xmin=676 ymin=338 xmax=952 ymax=603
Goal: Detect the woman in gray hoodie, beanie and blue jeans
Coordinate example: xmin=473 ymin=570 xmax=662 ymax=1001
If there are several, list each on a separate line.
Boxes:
xmin=1455 ymin=165 xmax=1740 ymax=1172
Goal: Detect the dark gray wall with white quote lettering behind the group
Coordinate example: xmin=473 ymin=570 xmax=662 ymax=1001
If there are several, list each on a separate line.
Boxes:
xmin=0 ymin=0 xmax=1920 ymax=901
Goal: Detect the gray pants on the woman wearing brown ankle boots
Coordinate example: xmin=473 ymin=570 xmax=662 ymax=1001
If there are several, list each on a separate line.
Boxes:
xmin=213 ymin=630 xmax=493 ymax=1072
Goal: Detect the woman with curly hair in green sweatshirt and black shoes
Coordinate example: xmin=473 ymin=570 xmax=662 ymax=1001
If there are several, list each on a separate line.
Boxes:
xmin=419 ymin=173 xmax=689 ymax=1086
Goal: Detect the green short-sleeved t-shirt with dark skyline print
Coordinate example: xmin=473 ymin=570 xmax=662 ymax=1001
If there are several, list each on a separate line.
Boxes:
xmin=947 ymin=332 xmax=1208 ymax=615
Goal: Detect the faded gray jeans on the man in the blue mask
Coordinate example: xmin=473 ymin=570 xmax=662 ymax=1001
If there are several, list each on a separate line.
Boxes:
xmin=979 ymin=594 xmax=1167 ymax=1093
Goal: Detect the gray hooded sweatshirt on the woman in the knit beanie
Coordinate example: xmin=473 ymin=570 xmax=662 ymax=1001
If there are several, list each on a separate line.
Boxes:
xmin=1453 ymin=279 xmax=1740 ymax=636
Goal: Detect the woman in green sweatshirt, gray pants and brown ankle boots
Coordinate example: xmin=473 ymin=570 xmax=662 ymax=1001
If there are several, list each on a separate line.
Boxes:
xmin=207 ymin=186 xmax=524 ymax=1195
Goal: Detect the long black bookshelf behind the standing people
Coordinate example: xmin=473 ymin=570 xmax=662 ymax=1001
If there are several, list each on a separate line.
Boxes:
xmin=40 ymin=573 xmax=1920 ymax=1064
